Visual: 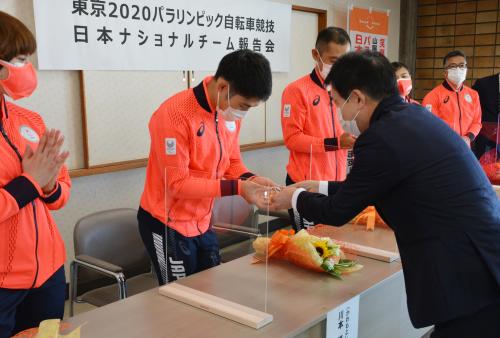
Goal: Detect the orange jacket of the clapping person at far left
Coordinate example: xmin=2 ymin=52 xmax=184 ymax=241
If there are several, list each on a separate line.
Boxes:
xmin=0 ymin=99 xmax=71 ymax=289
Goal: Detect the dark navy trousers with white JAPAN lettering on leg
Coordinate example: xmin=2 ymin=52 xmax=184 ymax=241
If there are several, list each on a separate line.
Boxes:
xmin=137 ymin=208 xmax=220 ymax=285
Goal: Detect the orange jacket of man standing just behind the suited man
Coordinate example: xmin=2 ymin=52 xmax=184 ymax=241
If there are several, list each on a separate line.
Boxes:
xmin=281 ymin=68 xmax=347 ymax=182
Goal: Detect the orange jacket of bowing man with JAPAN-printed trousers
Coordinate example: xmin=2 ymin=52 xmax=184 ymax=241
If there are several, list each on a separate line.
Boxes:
xmin=141 ymin=77 xmax=254 ymax=237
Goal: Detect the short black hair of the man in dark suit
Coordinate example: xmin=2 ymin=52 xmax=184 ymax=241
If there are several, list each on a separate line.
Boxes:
xmin=325 ymin=50 xmax=398 ymax=100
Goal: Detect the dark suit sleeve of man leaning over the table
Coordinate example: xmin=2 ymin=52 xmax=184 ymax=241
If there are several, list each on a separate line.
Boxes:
xmin=297 ymin=135 xmax=400 ymax=226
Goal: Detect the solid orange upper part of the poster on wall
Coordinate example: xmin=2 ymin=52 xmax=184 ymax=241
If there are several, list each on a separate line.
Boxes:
xmin=349 ymin=7 xmax=389 ymax=35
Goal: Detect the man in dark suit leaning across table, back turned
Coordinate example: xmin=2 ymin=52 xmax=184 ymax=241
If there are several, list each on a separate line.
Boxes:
xmin=271 ymin=51 xmax=500 ymax=338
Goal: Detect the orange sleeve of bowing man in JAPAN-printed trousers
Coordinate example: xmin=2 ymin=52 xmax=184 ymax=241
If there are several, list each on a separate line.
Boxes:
xmin=149 ymin=108 xmax=239 ymax=199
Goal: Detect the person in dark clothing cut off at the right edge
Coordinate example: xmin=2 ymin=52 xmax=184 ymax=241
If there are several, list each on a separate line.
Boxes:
xmin=472 ymin=73 xmax=500 ymax=159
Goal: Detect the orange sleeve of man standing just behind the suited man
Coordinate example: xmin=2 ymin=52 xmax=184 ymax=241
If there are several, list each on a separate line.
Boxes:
xmin=281 ymin=86 xmax=340 ymax=154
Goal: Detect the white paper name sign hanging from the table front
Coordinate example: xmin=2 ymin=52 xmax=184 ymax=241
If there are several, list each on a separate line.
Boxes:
xmin=326 ymin=296 xmax=359 ymax=338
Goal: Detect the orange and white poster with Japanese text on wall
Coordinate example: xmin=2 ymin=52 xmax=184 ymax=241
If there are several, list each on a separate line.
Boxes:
xmin=349 ymin=7 xmax=389 ymax=56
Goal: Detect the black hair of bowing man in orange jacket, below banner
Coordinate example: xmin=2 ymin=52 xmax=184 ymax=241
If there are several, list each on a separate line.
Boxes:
xmin=215 ymin=49 xmax=273 ymax=101
